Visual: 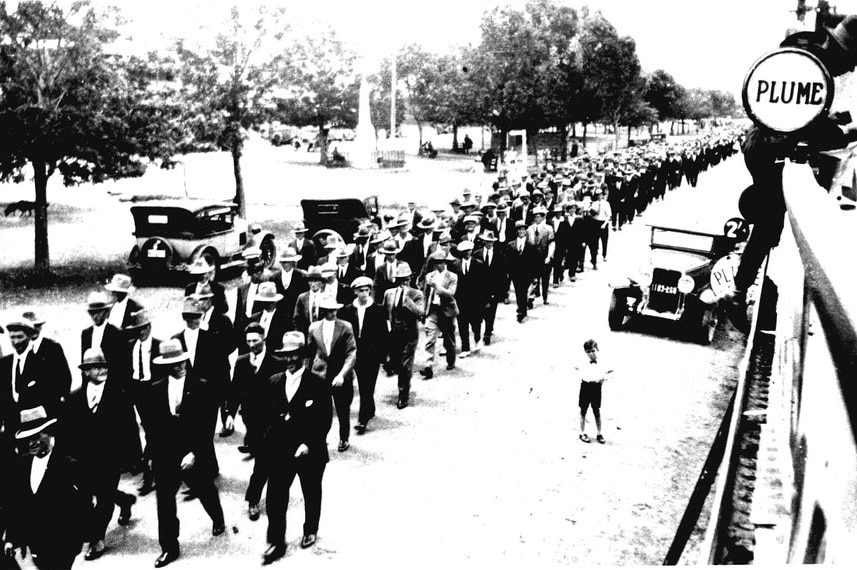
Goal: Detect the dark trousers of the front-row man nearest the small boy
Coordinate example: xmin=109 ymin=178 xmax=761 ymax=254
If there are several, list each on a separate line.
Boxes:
xmin=265 ymin=455 xmax=327 ymax=546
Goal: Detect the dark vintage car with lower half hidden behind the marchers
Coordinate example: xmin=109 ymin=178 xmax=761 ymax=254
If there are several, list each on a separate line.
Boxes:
xmin=301 ymin=196 xmax=378 ymax=246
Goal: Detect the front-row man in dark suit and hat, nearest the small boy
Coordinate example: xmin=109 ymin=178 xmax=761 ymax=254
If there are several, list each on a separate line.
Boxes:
xmin=262 ymin=331 xmax=333 ymax=565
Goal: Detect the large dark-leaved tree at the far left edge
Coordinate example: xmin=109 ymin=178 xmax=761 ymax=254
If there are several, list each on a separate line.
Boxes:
xmin=0 ymin=1 xmax=175 ymax=273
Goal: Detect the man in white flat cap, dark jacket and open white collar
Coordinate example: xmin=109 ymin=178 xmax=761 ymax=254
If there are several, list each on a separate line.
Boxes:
xmin=339 ymin=277 xmax=388 ymax=435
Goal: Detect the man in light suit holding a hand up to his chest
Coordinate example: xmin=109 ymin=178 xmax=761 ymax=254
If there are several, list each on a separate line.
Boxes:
xmin=420 ymin=251 xmax=458 ymax=380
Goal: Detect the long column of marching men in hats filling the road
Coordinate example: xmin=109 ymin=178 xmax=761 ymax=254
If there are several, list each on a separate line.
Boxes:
xmin=0 ymin=126 xmax=738 ymax=569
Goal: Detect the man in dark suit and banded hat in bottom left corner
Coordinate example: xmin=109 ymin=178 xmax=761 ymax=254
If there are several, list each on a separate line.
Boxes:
xmin=4 ymin=406 xmax=92 ymax=570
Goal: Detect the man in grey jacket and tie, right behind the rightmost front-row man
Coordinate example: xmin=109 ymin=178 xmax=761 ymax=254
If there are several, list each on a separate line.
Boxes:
xmin=307 ymin=296 xmax=357 ymax=452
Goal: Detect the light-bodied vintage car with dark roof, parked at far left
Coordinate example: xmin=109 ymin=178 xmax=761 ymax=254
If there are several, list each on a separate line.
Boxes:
xmin=128 ymin=200 xmax=277 ymax=274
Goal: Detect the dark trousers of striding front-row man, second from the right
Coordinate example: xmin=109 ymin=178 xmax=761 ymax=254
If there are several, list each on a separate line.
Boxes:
xmin=154 ymin=454 xmax=223 ymax=552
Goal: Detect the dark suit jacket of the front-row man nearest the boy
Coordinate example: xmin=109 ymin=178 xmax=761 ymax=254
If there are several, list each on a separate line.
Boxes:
xmin=263 ymin=367 xmax=333 ymax=464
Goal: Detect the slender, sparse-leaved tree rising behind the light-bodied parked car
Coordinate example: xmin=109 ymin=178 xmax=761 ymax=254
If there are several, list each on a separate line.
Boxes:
xmin=176 ymin=3 xmax=286 ymax=216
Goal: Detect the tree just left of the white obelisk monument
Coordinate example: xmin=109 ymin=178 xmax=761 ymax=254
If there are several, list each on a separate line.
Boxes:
xmin=276 ymin=30 xmax=360 ymax=164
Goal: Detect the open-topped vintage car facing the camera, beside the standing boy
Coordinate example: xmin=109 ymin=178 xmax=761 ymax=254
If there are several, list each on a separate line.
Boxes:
xmin=607 ymin=223 xmax=745 ymax=344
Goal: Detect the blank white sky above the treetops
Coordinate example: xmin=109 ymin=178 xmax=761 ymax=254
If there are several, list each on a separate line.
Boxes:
xmin=75 ymin=0 xmax=857 ymax=96
